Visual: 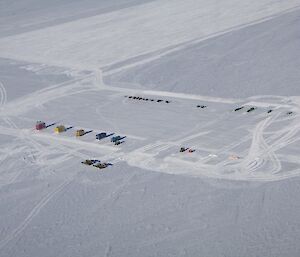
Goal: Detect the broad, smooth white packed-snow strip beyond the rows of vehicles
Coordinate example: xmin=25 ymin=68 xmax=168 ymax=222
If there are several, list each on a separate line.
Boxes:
xmin=0 ymin=0 xmax=299 ymax=69
